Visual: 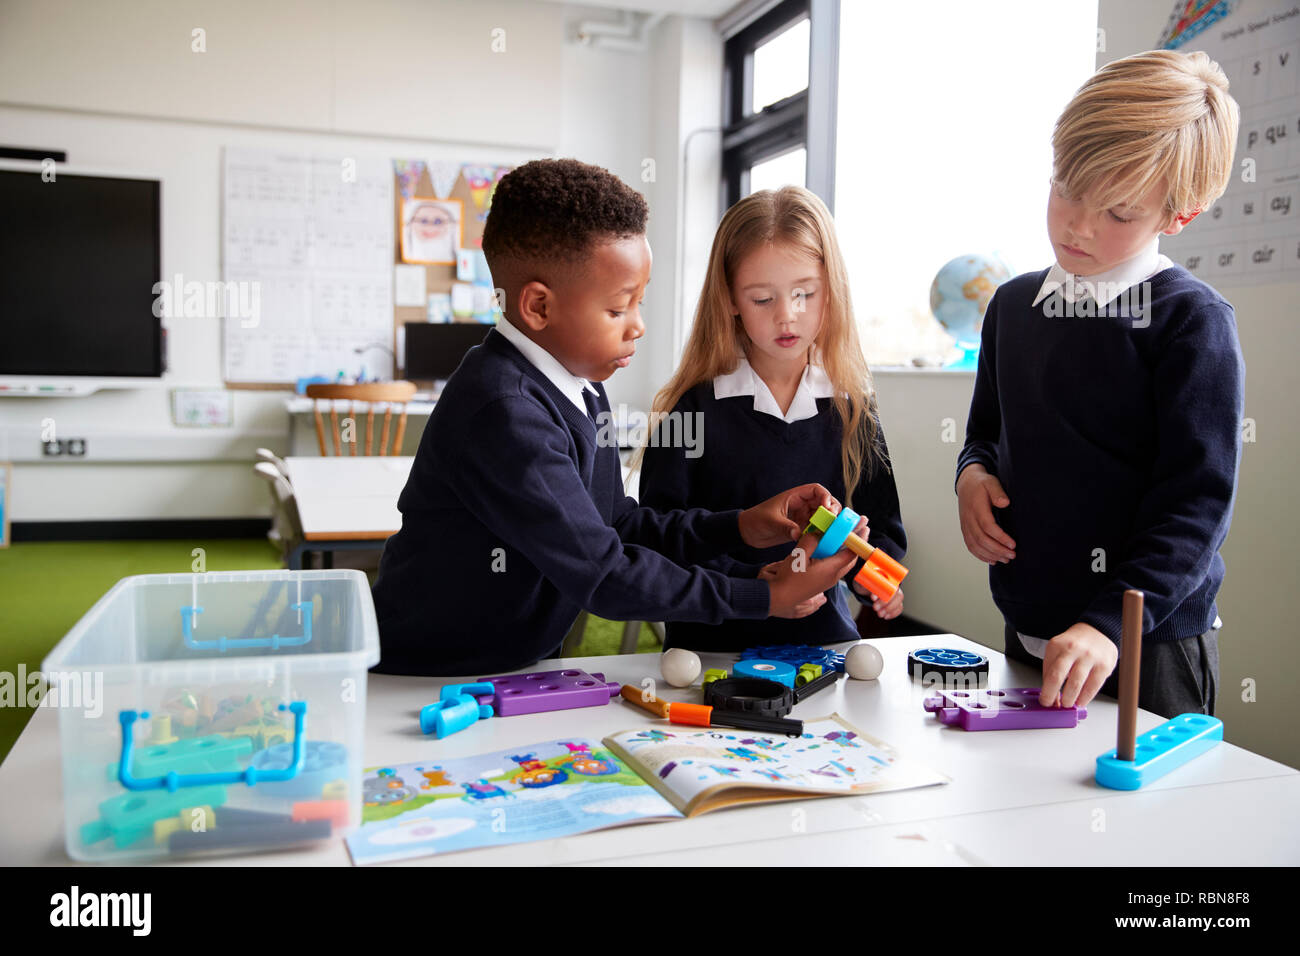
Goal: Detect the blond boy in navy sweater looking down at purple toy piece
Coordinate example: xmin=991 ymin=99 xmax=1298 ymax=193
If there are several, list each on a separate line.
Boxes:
xmin=957 ymin=51 xmax=1245 ymax=717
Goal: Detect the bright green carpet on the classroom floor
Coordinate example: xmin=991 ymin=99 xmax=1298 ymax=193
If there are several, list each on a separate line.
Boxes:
xmin=0 ymin=538 xmax=659 ymax=760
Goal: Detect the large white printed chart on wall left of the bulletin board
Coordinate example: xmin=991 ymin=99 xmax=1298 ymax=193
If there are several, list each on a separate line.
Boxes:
xmin=222 ymin=148 xmax=393 ymax=385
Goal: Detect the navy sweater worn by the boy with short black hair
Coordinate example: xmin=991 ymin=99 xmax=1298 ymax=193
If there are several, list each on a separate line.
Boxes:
xmin=373 ymin=329 xmax=770 ymax=676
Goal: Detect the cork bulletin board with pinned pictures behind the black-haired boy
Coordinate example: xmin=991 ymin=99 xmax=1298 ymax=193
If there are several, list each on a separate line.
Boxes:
xmin=393 ymin=160 xmax=511 ymax=371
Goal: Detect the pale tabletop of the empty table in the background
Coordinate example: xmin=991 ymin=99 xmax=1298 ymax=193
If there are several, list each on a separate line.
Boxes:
xmin=285 ymin=455 xmax=415 ymax=541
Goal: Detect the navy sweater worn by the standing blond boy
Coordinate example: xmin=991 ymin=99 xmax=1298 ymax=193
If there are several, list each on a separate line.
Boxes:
xmin=957 ymin=265 xmax=1245 ymax=641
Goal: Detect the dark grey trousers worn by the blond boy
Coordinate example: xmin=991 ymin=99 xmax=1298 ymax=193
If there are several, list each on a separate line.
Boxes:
xmin=1006 ymin=624 xmax=1218 ymax=718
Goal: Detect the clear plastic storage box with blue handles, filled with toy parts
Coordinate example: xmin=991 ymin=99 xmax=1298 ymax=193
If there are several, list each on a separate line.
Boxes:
xmin=42 ymin=570 xmax=380 ymax=862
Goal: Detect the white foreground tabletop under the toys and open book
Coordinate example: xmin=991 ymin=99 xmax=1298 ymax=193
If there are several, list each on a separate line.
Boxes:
xmin=0 ymin=635 xmax=1300 ymax=866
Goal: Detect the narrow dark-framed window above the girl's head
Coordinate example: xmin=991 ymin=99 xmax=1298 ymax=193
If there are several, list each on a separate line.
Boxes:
xmin=723 ymin=0 xmax=837 ymax=207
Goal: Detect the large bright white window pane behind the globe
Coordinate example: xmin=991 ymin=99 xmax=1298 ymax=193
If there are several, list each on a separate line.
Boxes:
xmin=835 ymin=0 xmax=1099 ymax=365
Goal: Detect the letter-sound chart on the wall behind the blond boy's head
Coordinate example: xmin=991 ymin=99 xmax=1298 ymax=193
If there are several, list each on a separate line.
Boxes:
xmin=1158 ymin=0 xmax=1300 ymax=287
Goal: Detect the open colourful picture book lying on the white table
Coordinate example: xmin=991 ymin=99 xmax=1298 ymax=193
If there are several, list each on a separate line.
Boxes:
xmin=347 ymin=715 xmax=948 ymax=864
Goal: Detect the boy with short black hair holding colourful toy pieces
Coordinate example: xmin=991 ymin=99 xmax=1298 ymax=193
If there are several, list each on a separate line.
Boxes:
xmin=373 ymin=160 xmax=853 ymax=675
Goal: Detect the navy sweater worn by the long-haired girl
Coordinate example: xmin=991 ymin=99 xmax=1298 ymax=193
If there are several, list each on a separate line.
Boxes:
xmin=640 ymin=382 xmax=907 ymax=650
